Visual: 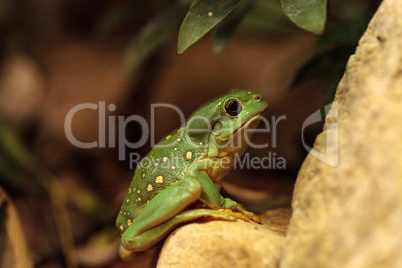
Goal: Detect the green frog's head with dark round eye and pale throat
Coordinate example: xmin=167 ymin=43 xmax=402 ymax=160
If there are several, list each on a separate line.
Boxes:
xmin=187 ymin=89 xmax=268 ymax=157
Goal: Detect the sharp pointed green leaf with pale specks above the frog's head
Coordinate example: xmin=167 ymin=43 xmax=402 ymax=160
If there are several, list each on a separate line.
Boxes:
xmin=177 ymin=0 xmax=243 ymax=53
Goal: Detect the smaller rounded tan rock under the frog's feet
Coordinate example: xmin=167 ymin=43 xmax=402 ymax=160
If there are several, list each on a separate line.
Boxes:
xmin=157 ymin=220 xmax=284 ymax=268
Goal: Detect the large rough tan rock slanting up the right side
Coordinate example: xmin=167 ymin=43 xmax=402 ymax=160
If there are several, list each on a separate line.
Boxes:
xmin=280 ymin=0 xmax=402 ymax=268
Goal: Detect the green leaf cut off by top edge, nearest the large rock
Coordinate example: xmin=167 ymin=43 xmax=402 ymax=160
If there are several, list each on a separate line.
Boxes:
xmin=281 ymin=0 xmax=327 ymax=34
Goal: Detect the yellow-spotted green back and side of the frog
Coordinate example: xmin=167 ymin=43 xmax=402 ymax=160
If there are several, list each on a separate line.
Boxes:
xmin=116 ymin=125 xmax=203 ymax=233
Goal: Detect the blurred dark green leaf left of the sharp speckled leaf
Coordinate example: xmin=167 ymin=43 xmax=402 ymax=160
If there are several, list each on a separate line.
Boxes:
xmin=126 ymin=7 xmax=186 ymax=76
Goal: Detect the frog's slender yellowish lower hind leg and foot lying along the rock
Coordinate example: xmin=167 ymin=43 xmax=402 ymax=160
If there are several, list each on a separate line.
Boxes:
xmin=120 ymin=209 xmax=244 ymax=255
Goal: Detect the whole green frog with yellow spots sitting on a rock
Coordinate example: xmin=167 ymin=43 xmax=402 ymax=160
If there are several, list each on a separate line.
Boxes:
xmin=116 ymin=89 xmax=268 ymax=258
